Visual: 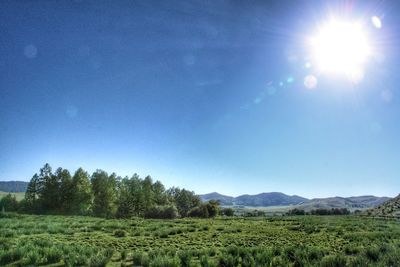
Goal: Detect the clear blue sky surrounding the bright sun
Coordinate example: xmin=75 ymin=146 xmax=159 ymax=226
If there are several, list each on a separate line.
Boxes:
xmin=0 ymin=0 xmax=400 ymax=197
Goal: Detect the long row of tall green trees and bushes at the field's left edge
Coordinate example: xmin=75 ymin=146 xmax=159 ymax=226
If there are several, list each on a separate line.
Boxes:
xmin=0 ymin=164 xmax=220 ymax=218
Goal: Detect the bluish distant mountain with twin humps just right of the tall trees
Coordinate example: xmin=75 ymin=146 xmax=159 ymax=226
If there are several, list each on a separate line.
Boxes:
xmin=200 ymin=192 xmax=308 ymax=207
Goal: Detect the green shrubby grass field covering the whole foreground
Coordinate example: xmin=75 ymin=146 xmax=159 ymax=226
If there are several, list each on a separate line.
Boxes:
xmin=0 ymin=214 xmax=400 ymax=267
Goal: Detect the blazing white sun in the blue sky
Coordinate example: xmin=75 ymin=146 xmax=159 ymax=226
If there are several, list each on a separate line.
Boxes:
xmin=310 ymin=19 xmax=371 ymax=81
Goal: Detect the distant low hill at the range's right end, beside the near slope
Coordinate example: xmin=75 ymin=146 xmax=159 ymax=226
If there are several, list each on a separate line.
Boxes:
xmin=298 ymin=196 xmax=390 ymax=211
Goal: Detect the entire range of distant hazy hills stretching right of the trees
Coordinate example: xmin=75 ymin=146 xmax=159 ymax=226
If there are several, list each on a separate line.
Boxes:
xmin=200 ymin=192 xmax=390 ymax=211
